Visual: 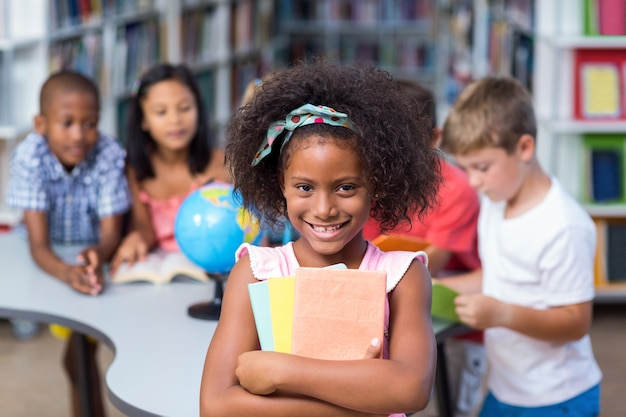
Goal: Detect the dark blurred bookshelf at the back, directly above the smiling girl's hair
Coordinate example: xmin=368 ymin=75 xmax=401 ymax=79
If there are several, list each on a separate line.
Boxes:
xmin=278 ymin=0 xmax=442 ymax=94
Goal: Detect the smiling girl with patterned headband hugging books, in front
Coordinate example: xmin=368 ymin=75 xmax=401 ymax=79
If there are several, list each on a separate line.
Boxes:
xmin=200 ymin=62 xmax=440 ymax=417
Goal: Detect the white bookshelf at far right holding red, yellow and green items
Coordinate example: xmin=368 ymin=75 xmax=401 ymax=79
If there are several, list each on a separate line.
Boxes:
xmin=533 ymin=0 xmax=626 ymax=302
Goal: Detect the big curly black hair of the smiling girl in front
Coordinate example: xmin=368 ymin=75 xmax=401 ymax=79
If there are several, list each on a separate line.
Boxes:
xmin=225 ymin=60 xmax=441 ymax=232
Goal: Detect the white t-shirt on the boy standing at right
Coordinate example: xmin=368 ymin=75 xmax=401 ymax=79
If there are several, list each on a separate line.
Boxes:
xmin=478 ymin=178 xmax=602 ymax=407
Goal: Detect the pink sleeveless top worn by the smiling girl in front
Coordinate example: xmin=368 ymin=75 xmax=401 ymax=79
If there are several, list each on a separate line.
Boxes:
xmin=235 ymin=242 xmax=428 ymax=417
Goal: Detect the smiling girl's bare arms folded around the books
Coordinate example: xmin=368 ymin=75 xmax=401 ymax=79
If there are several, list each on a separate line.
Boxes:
xmin=203 ymin=263 xmax=436 ymax=416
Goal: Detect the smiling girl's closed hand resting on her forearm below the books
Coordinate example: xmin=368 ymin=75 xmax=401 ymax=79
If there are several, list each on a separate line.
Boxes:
xmin=235 ymin=350 xmax=284 ymax=395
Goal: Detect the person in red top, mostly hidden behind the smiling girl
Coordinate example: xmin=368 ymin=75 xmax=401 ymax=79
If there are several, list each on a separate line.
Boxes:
xmin=363 ymin=79 xmax=487 ymax=417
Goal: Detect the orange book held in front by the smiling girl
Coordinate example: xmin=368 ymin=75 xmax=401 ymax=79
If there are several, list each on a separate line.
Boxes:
xmin=291 ymin=267 xmax=387 ymax=360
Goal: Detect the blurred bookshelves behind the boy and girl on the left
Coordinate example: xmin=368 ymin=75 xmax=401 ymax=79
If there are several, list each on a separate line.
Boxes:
xmin=0 ymin=0 xmax=277 ymax=225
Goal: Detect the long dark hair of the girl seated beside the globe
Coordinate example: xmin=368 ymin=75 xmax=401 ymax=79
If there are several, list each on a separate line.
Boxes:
xmin=126 ymin=63 xmax=214 ymax=181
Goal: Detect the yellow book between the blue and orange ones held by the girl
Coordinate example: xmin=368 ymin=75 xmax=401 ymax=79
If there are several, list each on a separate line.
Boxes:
xmin=267 ymin=277 xmax=296 ymax=353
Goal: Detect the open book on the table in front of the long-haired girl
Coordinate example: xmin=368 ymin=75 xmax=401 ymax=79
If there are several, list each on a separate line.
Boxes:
xmin=111 ymin=250 xmax=210 ymax=284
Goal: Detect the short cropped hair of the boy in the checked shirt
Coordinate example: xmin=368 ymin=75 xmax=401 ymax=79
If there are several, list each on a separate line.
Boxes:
xmin=39 ymin=69 xmax=100 ymax=114
